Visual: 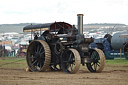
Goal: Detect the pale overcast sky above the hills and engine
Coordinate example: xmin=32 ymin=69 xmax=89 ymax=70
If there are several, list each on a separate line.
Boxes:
xmin=0 ymin=0 xmax=128 ymax=25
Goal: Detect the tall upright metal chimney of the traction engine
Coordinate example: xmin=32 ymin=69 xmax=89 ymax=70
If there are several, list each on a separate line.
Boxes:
xmin=77 ymin=14 xmax=84 ymax=35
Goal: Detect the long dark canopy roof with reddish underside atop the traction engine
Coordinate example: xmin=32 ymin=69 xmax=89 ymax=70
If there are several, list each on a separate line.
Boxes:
xmin=23 ymin=22 xmax=72 ymax=32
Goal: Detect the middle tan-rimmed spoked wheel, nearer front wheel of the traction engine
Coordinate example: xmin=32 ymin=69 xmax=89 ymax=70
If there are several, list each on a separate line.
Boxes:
xmin=62 ymin=49 xmax=81 ymax=74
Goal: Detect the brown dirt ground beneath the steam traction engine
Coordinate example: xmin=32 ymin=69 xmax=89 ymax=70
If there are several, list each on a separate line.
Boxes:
xmin=0 ymin=65 xmax=128 ymax=85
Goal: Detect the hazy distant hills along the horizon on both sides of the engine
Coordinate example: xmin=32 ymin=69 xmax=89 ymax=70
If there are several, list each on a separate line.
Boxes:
xmin=0 ymin=23 xmax=127 ymax=33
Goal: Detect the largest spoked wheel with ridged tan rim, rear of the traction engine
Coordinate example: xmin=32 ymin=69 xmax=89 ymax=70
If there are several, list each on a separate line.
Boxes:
xmin=26 ymin=40 xmax=51 ymax=72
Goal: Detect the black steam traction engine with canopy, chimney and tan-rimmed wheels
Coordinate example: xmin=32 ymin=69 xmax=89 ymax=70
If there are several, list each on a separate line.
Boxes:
xmin=23 ymin=14 xmax=105 ymax=73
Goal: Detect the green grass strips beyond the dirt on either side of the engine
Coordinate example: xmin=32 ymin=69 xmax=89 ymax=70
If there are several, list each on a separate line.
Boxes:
xmin=0 ymin=57 xmax=128 ymax=68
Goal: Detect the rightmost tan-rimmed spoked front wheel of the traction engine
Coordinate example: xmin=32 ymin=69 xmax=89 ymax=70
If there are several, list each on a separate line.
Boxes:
xmin=86 ymin=49 xmax=105 ymax=72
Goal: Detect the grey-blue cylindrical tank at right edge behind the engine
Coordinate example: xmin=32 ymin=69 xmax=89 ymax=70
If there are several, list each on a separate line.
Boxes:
xmin=111 ymin=32 xmax=128 ymax=50
